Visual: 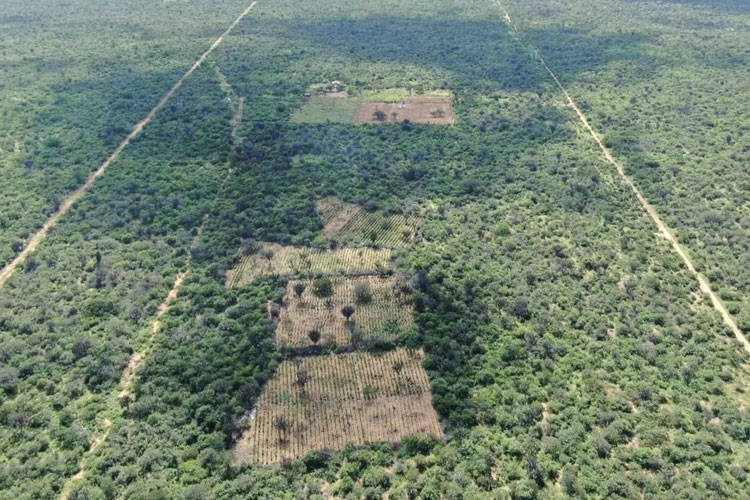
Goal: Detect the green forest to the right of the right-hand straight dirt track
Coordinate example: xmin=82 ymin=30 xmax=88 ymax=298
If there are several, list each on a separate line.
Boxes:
xmin=506 ymin=0 xmax=750 ymax=331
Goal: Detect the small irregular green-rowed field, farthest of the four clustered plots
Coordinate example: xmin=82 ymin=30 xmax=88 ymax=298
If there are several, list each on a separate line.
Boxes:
xmin=317 ymin=198 xmax=422 ymax=247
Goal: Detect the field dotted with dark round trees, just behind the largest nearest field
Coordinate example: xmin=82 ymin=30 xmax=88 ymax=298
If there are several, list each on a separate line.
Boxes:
xmin=276 ymin=276 xmax=413 ymax=347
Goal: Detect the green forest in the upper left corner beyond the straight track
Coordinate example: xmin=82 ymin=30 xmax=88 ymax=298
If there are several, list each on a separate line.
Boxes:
xmin=0 ymin=0 xmax=253 ymax=265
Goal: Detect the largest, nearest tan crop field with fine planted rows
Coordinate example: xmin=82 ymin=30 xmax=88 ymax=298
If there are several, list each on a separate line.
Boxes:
xmin=235 ymin=349 xmax=442 ymax=465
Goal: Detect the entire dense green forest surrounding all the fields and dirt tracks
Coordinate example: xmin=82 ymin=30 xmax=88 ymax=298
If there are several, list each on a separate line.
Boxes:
xmin=0 ymin=0 xmax=750 ymax=499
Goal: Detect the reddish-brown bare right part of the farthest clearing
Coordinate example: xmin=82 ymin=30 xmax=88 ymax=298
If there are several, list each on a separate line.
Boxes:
xmin=354 ymin=97 xmax=454 ymax=125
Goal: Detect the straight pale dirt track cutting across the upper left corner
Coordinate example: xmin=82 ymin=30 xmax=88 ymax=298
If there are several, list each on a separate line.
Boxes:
xmin=0 ymin=1 xmax=258 ymax=288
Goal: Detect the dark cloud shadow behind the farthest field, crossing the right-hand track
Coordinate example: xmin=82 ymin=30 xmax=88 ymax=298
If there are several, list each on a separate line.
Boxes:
xmin=260 ymin=15 xmax=669 ymax=93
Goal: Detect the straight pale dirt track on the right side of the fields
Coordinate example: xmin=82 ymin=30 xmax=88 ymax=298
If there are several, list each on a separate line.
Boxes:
xmin=495 ymin=0 xmax=750 ymax=353
